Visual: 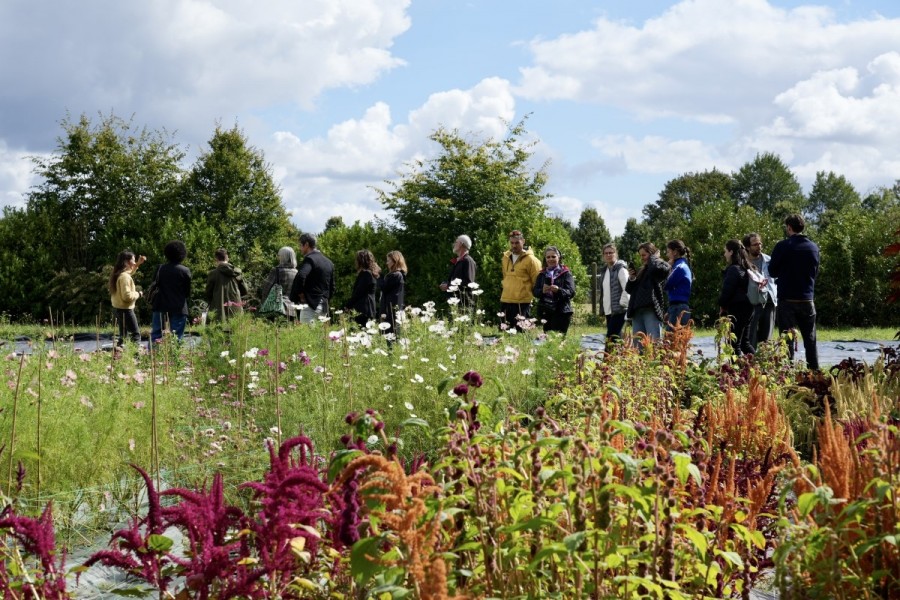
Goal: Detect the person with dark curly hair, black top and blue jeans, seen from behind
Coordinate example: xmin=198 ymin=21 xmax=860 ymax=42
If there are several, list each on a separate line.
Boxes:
xmin=150 ymin=240 xmax=191 ymax=344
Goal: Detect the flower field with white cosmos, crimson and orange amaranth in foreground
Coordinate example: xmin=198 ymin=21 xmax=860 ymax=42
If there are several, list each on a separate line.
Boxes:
xmin=0 ymin=305 xmax=900 ymax=599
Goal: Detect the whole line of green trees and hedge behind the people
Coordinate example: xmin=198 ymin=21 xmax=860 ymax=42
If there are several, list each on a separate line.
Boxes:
xmin=0 ymin=115 xmax=900 ymax=325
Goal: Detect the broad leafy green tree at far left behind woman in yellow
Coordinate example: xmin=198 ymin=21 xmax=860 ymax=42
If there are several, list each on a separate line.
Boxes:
xmin=14 ymin=110 xmax=183 ymax=322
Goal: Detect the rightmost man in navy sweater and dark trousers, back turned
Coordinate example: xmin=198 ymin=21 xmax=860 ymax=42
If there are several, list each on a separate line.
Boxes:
xmin=769 ymin=215 xmax=819 ymax=370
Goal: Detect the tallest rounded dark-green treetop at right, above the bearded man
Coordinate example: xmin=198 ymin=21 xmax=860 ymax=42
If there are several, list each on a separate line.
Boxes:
xmin=732 ymin=152 xmax=806 ymax=219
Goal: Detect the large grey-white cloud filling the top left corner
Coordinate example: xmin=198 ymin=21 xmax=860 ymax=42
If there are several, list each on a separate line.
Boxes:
xmin=0 ymin=0 xmax=410 ymax=146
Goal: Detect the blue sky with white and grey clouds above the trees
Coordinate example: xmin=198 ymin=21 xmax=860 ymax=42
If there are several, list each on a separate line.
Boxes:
xmin=0 ymin=0 xmax=900 ymax=236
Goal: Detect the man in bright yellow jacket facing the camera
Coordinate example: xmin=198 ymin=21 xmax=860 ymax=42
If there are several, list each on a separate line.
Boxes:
xmin=500 ymin=229 xmax=541 ymax=330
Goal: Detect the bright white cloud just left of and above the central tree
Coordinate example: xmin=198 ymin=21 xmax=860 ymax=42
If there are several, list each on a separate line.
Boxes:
xmin=264 ymin=78 xmax=515 ymax=231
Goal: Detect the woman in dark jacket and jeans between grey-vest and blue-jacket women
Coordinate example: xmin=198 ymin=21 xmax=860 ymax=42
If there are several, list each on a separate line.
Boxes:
xmin=625 ymin=242 xmax=669 ymax=347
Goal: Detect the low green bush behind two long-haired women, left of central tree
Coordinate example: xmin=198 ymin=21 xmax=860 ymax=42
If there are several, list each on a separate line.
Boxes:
xmin=318 ymin=217 xmax=400 ymax=309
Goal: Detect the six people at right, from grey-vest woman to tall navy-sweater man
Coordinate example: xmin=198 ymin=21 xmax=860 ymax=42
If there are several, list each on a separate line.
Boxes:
xmin=598 ymin=214 xmax=819 ymax=369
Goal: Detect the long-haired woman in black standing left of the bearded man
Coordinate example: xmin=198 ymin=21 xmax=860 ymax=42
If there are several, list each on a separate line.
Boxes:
xmin=719 ymin=239 xmax=756 ymax=356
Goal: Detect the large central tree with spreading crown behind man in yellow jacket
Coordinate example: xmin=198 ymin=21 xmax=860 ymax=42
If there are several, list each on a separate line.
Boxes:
xmin=378 ymin=122 xmax=580 ymax=310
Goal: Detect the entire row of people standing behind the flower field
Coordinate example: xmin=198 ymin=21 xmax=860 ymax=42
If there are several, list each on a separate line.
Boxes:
xmin=109 ymin=215 xmax=819 ymax=369
